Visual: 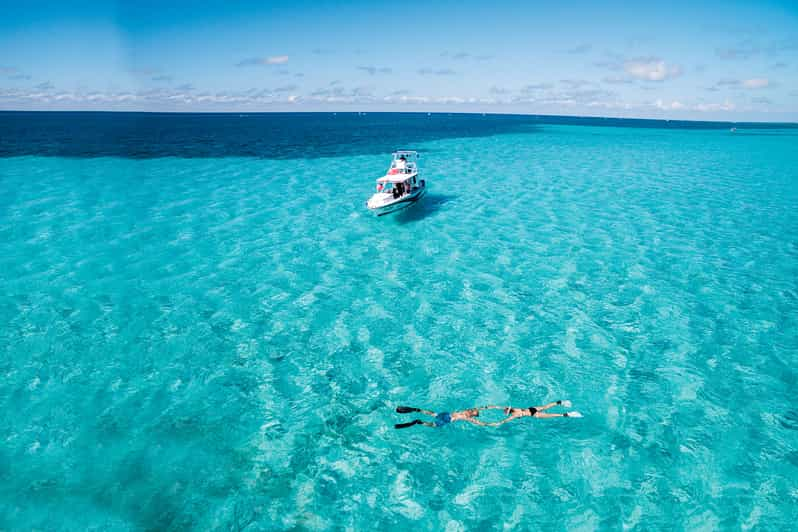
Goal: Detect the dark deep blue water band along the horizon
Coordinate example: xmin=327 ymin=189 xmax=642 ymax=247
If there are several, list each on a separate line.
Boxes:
xmin=0 ymin=112 xmax=798 ymax=159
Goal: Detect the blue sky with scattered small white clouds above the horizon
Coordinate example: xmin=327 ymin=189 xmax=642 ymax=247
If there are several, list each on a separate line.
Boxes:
xmin=0 ymin=0 xmax=798 ymax=122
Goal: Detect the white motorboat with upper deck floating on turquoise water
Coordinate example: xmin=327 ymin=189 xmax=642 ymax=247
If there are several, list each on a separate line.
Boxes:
xmin=366 ymin=150 xmax=427 ymax=216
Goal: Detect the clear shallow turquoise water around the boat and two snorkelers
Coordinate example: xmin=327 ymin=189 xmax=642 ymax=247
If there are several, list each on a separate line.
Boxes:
xmin=0 ymin=115 xmax=798 ymax=531
